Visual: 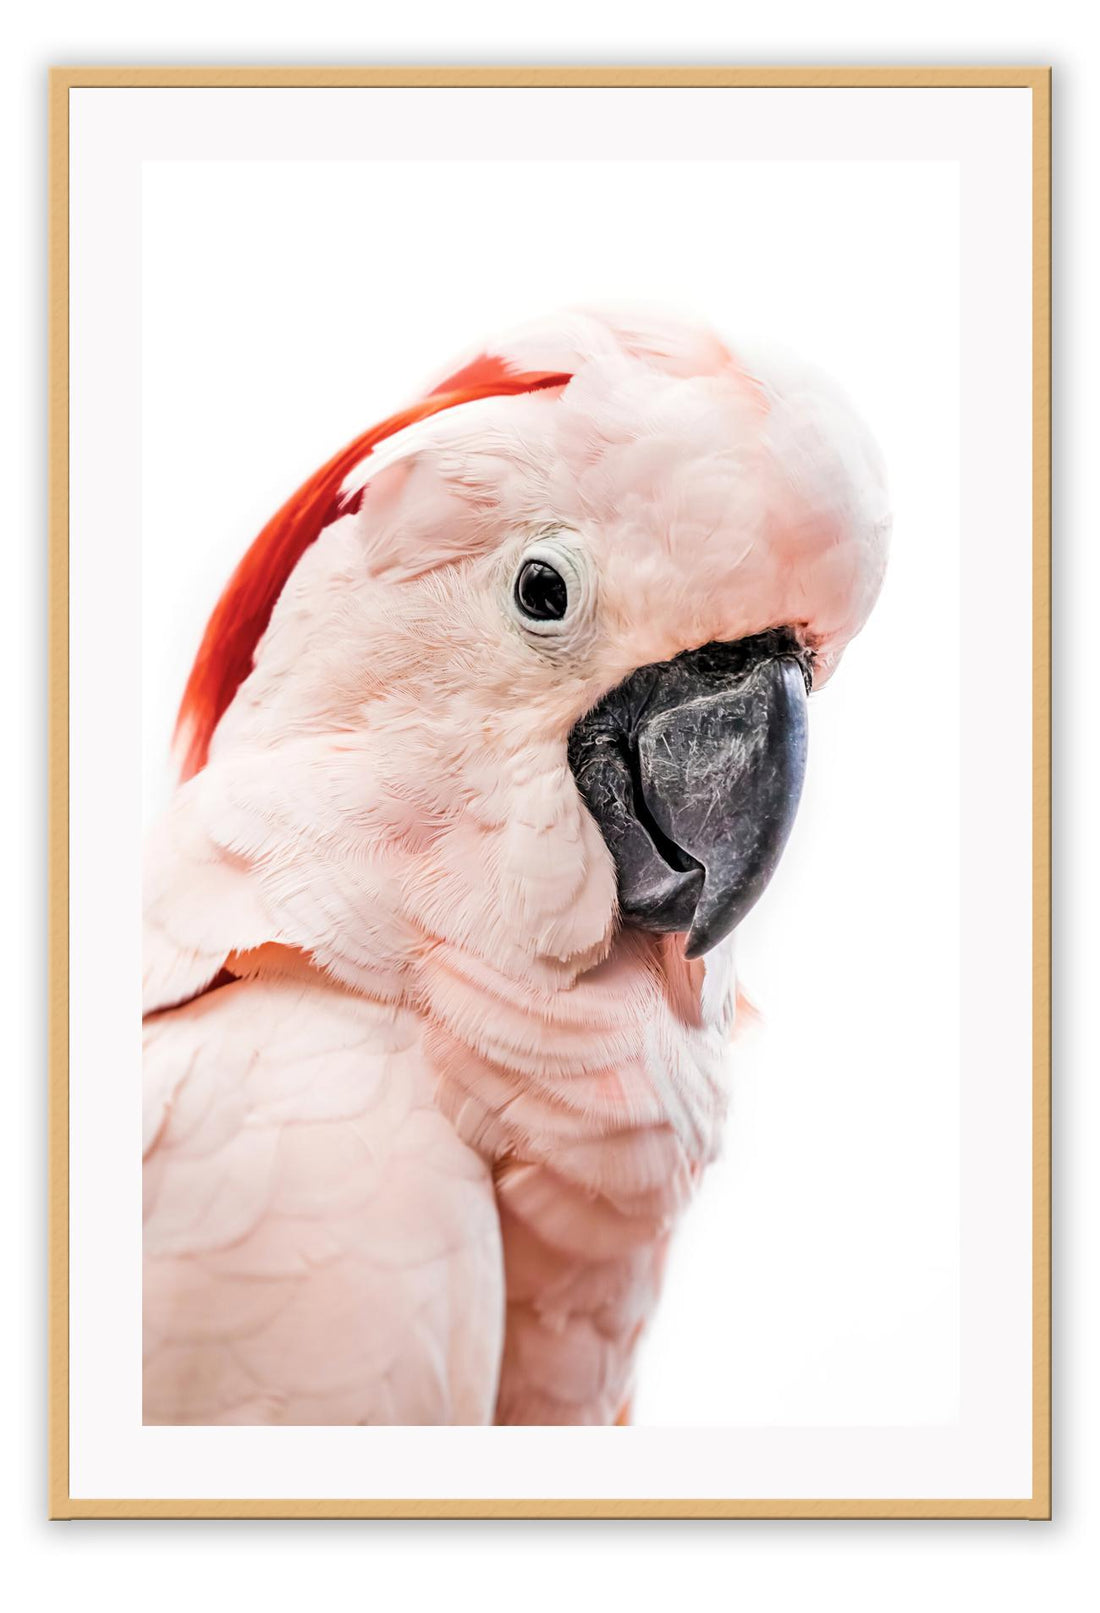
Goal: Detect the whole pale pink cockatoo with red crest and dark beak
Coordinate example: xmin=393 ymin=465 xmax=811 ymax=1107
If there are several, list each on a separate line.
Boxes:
xmin=144 ymin=315 xmax=889 ymax=1424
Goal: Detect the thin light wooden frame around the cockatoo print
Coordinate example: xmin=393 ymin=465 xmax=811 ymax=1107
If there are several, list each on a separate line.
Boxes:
xmin=48 ymin=66 xmax=1052 ymax=1519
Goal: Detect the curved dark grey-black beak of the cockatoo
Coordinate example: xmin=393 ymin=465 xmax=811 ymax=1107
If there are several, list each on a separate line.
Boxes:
xmin=569 ymin=629 xmax=810 ymax=958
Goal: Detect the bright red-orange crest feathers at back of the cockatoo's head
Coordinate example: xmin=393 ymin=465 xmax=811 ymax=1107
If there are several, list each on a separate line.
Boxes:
xmin=176 ymin=355 xmax=571 ymax=779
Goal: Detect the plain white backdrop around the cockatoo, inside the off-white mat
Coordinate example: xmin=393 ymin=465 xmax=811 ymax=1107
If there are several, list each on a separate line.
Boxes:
xmin=142 ymin=154 xmax=961 ymax=1428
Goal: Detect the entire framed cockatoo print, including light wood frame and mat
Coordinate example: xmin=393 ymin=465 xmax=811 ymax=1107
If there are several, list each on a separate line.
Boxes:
xmin=50 ymin=68 xmax=1050 ymax=1518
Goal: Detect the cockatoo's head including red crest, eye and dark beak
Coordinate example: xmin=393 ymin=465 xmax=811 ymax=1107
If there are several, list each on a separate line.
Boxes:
xmin=179 ymin=303 xmax=889 ymax=980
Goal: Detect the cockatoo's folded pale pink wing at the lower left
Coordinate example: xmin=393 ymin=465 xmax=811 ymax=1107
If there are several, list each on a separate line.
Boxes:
xmin=144 ymin=966 xmax=503 ymax=1424
